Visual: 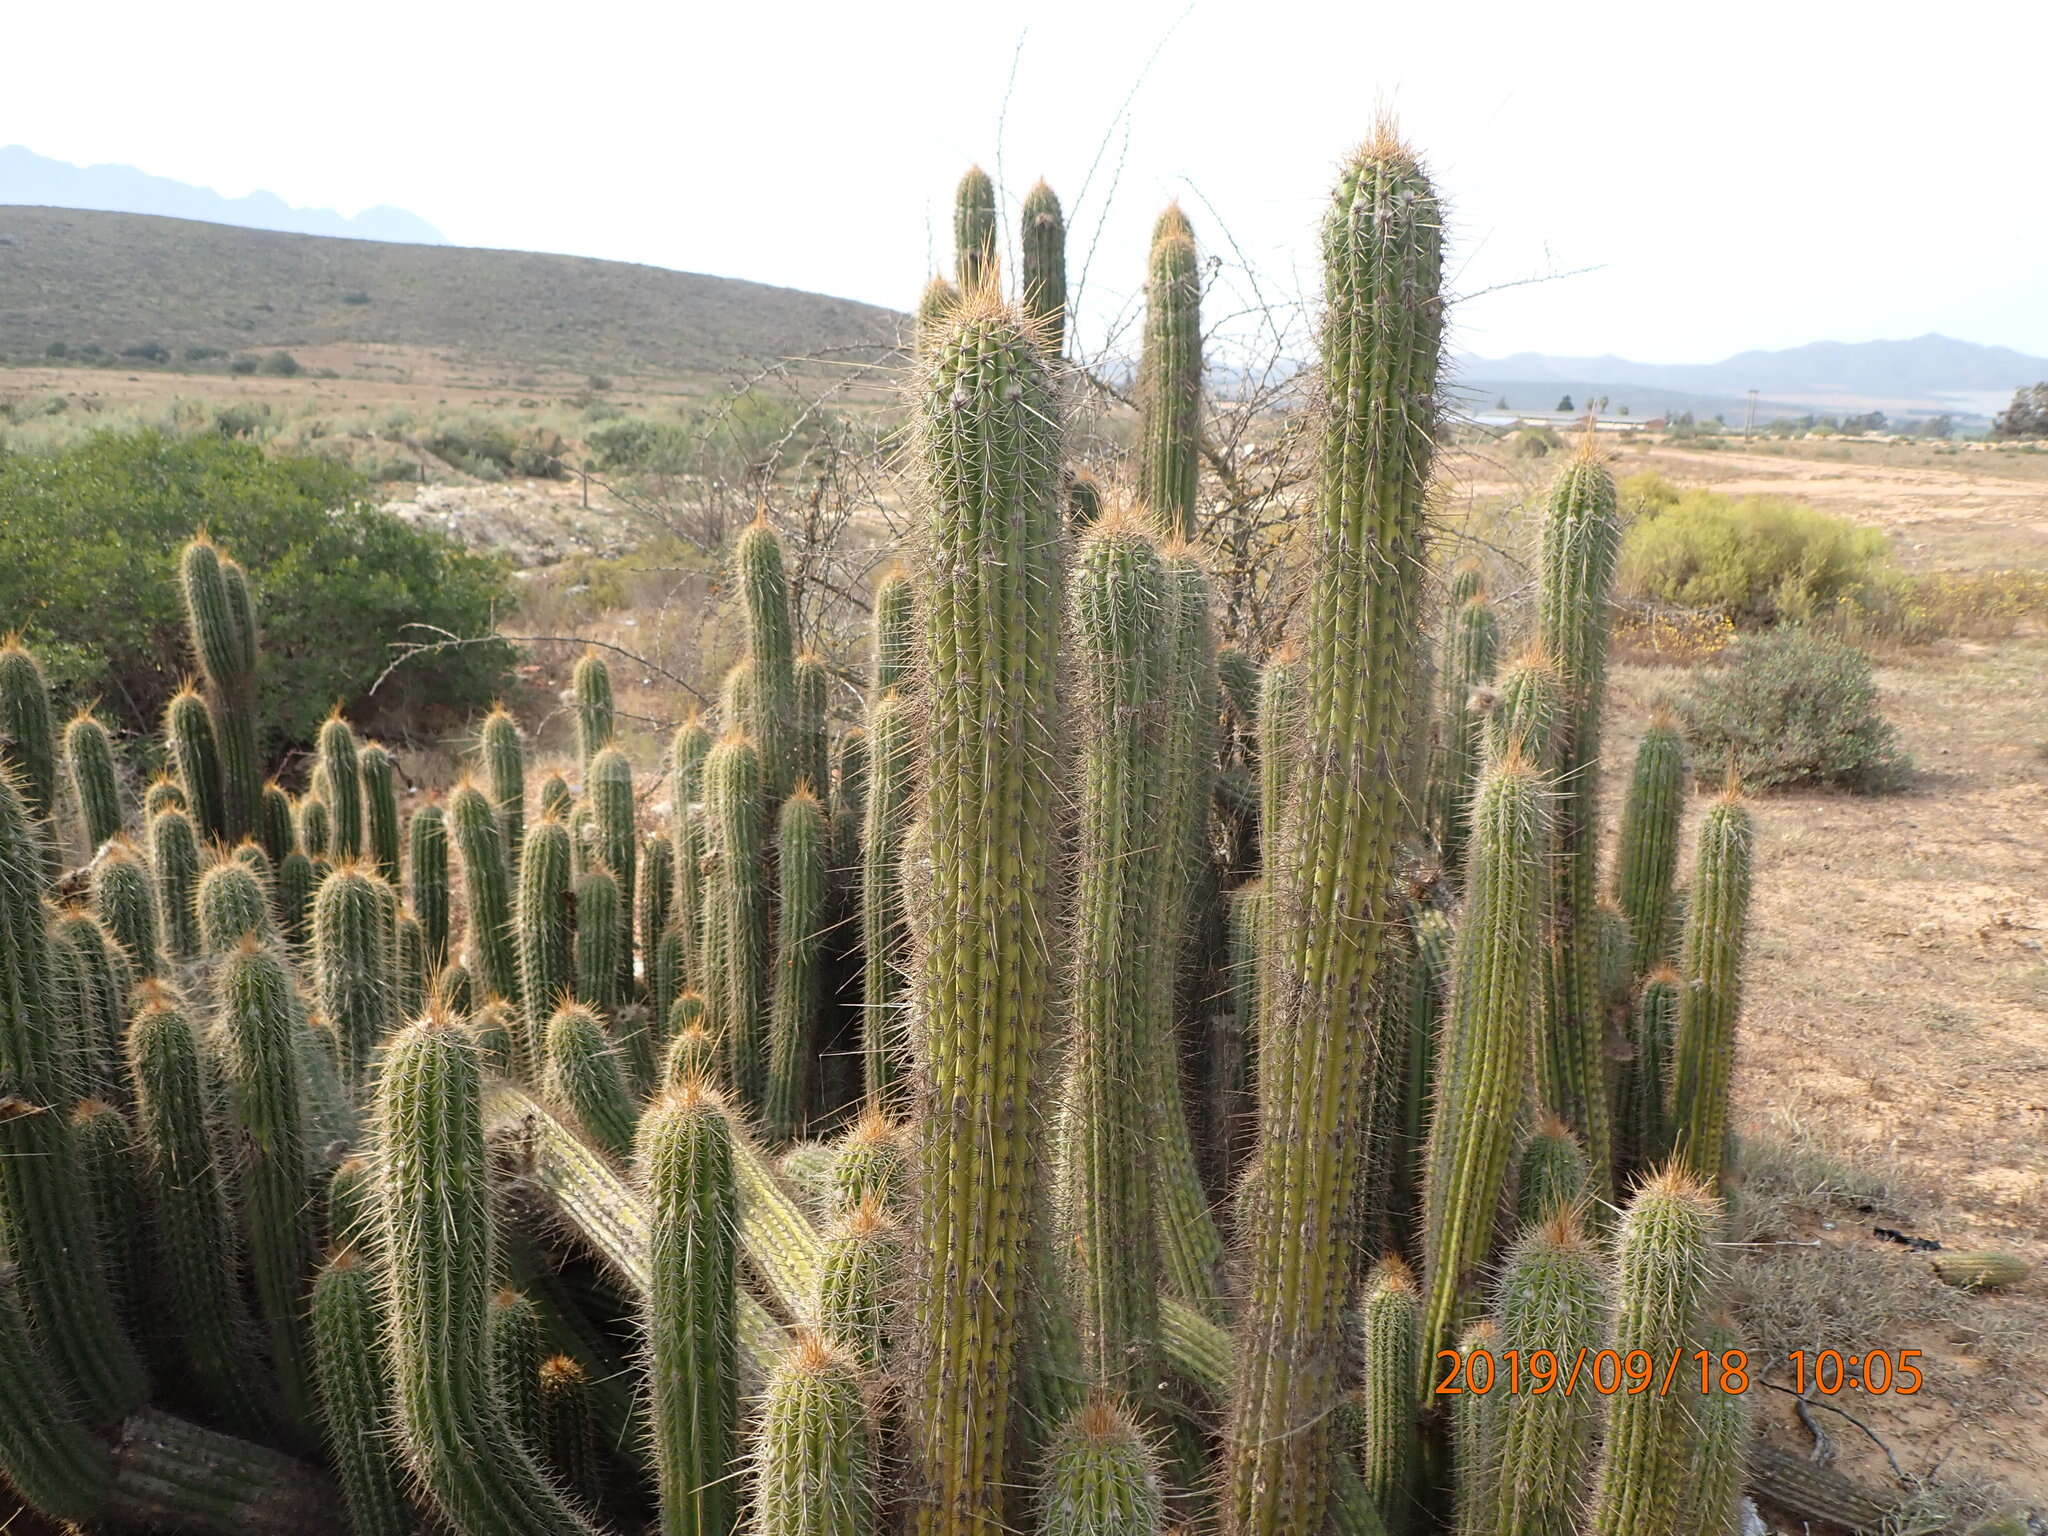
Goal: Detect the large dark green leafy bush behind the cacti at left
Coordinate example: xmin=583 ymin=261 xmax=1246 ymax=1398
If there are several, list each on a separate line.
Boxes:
xmin=0 ymin=432 xmax=510 ymax=748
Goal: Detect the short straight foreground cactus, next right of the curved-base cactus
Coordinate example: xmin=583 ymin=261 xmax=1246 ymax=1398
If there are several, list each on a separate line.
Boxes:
xmin=639 ymin=1083 xmax=739 ymax=1536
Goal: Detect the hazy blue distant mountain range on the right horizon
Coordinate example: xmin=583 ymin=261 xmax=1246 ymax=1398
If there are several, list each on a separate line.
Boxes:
xmin=1458 ymin=334 xmax=2048 ymax=416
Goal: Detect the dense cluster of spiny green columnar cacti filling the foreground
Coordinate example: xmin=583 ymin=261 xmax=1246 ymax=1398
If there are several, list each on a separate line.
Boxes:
xmin=0 ymin=133 xmax=1777 ymax=1536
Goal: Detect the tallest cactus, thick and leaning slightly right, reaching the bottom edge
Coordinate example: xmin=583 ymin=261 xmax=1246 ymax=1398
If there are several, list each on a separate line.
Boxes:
xmin=1223 ymin=131 xmax=1444 ymax=1536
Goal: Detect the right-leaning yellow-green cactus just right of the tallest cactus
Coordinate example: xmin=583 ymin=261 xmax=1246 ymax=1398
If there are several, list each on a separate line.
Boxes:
xmin=1423 ymin=758 xmax=1548 ymax=1391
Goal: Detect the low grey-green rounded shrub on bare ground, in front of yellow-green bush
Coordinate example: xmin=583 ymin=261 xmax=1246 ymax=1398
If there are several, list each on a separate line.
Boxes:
xmin=1677 ymin=629 xmax=1913 ymax=795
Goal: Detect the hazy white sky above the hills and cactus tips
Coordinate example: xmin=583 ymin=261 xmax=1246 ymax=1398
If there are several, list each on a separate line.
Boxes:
xmin=16 ymin=0 xmax=2048 ymax=362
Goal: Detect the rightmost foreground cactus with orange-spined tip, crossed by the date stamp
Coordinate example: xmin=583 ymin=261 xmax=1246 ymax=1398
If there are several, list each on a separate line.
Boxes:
xmin=1585 ymin=1167 xmax=1720 ymax=1536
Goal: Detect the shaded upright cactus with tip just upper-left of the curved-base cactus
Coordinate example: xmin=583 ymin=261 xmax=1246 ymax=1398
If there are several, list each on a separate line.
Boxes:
xmin=213 ymin=932 xmax=315 ymax=1423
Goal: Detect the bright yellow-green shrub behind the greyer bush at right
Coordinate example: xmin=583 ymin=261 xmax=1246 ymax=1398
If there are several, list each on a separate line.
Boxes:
xmin=1620 ymin=489 xmax=1888 ymax=629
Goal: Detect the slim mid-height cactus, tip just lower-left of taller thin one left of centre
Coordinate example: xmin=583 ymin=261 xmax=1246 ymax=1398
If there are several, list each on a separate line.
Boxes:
xmin=705 ymin=735 xmax=768 ymax=1104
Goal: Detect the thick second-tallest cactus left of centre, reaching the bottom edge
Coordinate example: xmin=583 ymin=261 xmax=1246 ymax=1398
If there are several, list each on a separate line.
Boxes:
xmin=903 ymin=293 xmax=1061 ymax=1536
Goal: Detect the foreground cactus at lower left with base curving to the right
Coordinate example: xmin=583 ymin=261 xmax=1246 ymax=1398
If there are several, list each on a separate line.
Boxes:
xmin=377 ymin=1016 xmax=596 ymax=1536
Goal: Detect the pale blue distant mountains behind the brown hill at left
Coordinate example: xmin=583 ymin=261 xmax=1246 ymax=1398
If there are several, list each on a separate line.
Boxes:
xmin=0 ymin=143 xmax=446 ymax=246
